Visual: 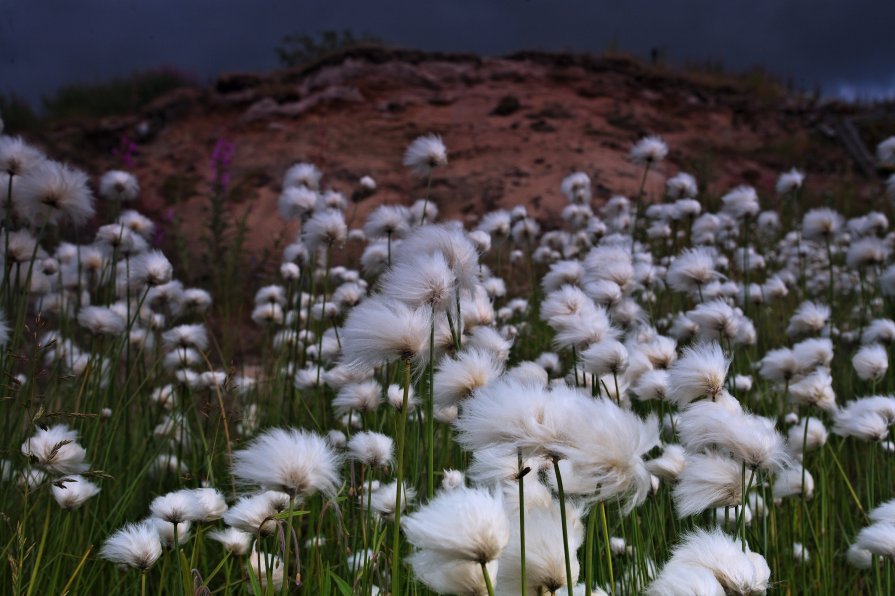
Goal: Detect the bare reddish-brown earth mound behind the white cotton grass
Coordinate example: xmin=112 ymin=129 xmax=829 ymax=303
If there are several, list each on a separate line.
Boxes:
xmin=36 ymin=49 xmax=880 ymax=258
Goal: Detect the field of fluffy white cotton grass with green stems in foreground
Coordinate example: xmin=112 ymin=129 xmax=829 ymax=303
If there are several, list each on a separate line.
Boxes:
xmin=0 ymin=114 xmax=895 ymax=596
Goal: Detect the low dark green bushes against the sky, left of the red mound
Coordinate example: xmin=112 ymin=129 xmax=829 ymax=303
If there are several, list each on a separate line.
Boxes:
xmin=43 ymin=68 xmax=196 ymax=119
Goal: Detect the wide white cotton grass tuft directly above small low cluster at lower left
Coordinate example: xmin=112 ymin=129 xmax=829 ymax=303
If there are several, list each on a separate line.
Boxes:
xmin=233 ymin=428 xmax=341 ymax=497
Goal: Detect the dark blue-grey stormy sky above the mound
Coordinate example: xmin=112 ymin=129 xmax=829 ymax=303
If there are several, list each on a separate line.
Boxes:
xmin=0 ymin=0 xmax=895 ymax=106
